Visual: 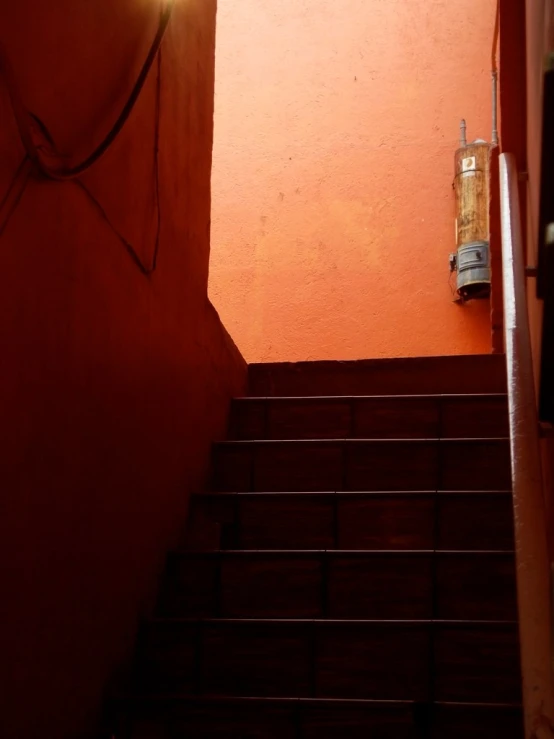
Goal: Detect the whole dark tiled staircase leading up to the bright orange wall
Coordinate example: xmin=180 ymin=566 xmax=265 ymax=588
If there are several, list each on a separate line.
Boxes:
xmin=116 ymin=356 xmax=523 ymax=739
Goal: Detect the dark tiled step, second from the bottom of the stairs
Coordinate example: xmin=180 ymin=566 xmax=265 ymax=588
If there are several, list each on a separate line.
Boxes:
xmin=139 ymin=619 xmax=520 ymax=703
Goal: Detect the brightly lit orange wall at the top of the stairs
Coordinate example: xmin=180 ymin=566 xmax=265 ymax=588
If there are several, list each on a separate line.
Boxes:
xmin=210 ymin=0 xmax=496 ymax=361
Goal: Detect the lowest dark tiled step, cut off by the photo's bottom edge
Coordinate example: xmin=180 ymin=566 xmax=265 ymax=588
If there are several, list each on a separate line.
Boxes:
xmin=116 ymin=697 xmax=523 ymax=739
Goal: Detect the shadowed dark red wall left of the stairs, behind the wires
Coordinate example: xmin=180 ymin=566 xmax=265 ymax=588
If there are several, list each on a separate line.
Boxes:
xmin=0 ymin=0 xmax=245 ymax=739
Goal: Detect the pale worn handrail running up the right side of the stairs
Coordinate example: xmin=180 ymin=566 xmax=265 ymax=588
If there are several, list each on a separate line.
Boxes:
xmin=500 ymin=154 xmax=554 ymax=739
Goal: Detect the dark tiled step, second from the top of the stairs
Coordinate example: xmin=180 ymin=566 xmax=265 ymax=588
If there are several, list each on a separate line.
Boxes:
xmin=230 ymin=395 xmax=509 ymax=439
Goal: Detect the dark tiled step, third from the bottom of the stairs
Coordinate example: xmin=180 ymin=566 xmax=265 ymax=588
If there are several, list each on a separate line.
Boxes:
xmin=160 ymin=551 xmax=517 ymax=620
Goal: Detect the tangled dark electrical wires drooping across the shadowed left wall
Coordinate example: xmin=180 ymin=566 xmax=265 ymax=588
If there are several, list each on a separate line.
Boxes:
xmin=0 ymin=0 xmax=175 ymax=275
